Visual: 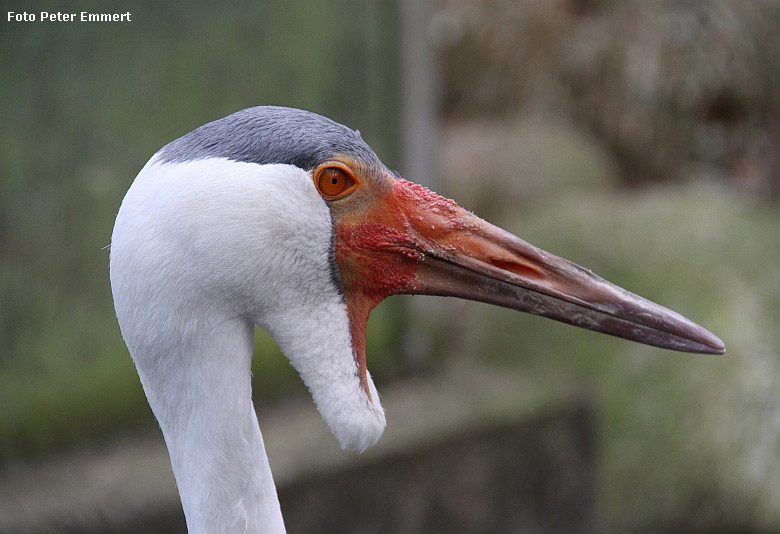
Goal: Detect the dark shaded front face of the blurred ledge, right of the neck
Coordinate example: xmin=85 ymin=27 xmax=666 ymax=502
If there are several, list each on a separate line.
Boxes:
xmin=279 ymin=403 xmax=597 ymax=534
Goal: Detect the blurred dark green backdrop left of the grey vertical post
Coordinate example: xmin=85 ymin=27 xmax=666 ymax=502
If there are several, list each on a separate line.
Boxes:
xmin=0 ymin=0 xmax=399 ymax=460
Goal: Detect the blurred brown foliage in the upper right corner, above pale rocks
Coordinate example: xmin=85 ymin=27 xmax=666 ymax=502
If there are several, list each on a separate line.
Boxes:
xmin=435 ymin=0 xmax=780 ymax=199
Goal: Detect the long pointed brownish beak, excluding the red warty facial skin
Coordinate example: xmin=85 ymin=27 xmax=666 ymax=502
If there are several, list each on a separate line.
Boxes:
xmin=408 ymin=211 xmax=726 ymax=354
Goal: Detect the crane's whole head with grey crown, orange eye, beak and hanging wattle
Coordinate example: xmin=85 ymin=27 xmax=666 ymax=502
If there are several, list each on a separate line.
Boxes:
xmin=111 ymin=107 xmax=725 ymax=456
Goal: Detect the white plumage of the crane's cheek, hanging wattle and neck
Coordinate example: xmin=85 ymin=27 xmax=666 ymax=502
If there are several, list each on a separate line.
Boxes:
xmin=110 ymin=156 xmax=385 ymax=532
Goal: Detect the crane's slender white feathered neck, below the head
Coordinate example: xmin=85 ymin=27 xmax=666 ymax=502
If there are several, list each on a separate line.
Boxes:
xmin=135 ymin=320 xmax=285 ymax=533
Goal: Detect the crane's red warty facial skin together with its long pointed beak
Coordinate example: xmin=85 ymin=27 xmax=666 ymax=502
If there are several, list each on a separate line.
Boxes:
xmin=336 ymin=178 xmax=726 ymax=399
